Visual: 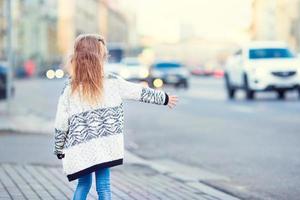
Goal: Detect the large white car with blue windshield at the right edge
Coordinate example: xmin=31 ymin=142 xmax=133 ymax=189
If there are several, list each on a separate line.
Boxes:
xmin=224 ymin=41 xmax=300 ymax=99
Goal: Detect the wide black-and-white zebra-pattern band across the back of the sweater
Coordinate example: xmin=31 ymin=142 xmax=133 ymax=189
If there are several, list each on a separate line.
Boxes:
xmin=65 ymin=104 xmax=124 ymax=148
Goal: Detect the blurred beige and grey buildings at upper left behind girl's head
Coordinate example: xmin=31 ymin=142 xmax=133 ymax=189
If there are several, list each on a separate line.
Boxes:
xmin=0 ymin=0 xmax=138 ymax=73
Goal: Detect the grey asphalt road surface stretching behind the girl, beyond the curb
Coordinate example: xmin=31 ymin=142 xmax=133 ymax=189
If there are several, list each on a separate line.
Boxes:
xmin=2 ymin=78 xmax=300 ymax=200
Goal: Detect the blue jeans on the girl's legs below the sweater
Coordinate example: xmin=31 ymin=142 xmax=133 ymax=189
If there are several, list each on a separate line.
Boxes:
xmin=73 ymin=168 xmax=111 ymax=200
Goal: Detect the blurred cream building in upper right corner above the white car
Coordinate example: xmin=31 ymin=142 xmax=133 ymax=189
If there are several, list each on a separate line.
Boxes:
xmin=250 ymin=0 xmax=300 ymax=49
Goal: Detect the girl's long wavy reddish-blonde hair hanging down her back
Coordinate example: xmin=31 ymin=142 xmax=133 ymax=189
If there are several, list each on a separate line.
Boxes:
xmin=71 ymin=34 xmax=107 ymax=105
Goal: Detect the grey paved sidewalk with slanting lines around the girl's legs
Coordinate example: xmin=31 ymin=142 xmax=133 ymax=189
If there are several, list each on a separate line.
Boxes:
xmin=0 ymin=164 xmax=232 ymax=200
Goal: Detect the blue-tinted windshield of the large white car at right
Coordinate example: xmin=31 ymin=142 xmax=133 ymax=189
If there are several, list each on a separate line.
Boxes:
xmin=249 ymin=48 xmax=294 ymax=59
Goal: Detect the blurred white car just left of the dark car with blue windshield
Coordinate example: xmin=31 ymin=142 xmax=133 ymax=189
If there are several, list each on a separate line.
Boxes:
xmin=120 ymin=57 xmax=149 ymax=81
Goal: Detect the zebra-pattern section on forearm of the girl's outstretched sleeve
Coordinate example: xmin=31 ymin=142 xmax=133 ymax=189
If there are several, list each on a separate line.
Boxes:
xmin=140 ymin=87 xmax=166 ymax=105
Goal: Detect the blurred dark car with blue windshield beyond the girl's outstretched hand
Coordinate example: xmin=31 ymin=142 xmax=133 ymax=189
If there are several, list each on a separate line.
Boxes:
xmin=148 ymin=61 xmax=189 ymax=88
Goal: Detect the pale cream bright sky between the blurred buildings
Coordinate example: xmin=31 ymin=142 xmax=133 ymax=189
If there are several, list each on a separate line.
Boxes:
xmin=137 ymin=0 xmax=252 ymax=42
